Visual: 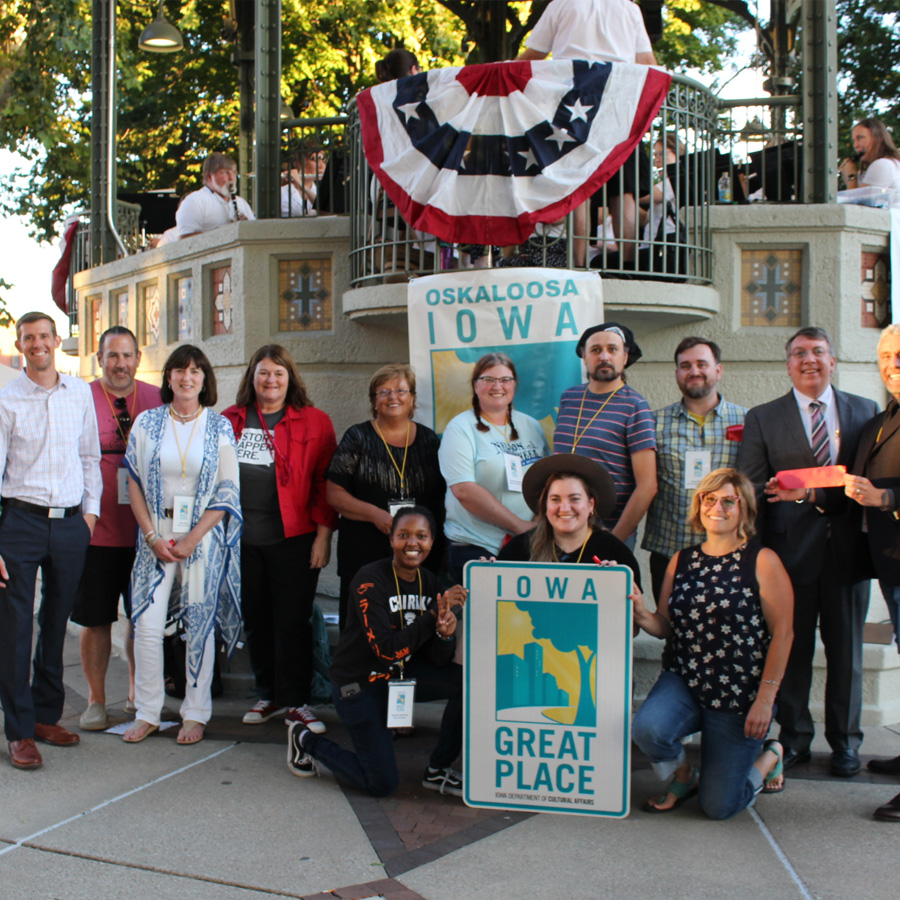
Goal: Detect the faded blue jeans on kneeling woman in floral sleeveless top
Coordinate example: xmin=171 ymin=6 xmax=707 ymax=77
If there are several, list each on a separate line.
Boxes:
xmin=632 ymin=672 xmax=763 ymax=819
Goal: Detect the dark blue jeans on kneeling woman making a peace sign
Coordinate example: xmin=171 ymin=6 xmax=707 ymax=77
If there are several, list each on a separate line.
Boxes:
xmin=303 ymin=660 xmax=462 ymax=797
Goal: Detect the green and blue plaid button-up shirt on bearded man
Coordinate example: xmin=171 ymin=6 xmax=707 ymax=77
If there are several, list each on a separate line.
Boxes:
xmin=641 ymin=396 xmax=747 ymax=557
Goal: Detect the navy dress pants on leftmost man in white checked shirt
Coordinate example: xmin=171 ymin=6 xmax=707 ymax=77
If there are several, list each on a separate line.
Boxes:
xmin=0 ymin=507 xmax=91 ymax=741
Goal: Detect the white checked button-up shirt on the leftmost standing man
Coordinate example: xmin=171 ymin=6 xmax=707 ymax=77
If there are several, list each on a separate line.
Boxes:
xmin=0 ymin=372 xmax=103 ymax=516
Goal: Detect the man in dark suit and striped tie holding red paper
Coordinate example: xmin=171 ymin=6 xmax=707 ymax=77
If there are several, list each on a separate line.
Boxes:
xmin=738 ymin=328 xmax=878 ymax=777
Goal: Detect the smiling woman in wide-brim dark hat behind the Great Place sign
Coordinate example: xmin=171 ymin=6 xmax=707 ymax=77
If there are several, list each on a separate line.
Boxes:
xmin=497 ymin=453 xmax=641 ymax=585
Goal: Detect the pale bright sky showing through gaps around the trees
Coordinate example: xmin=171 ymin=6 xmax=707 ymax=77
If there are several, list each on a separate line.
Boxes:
xmin=0 ymin=31 xmax=766 ymax=335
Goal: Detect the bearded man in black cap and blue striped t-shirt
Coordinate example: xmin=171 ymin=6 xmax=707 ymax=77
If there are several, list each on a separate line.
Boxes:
xmin=553 ymin=322 xmax=656 ymax=549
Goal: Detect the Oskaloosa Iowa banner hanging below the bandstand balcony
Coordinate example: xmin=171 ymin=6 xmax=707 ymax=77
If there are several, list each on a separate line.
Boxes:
xmin=408 ymin=268 xmax=603 ymax=440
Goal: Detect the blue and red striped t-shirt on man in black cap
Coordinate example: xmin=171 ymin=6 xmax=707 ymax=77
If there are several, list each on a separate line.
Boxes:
xmin=553 ymin=384 xmax=656 ymax=528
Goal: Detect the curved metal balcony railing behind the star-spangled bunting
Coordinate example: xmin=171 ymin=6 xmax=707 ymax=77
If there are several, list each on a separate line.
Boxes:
xmin=347 ymin=76 xmax=732 ymax=287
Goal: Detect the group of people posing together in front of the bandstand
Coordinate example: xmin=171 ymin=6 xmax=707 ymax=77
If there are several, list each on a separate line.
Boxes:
xmin=0 ymin=313 xmax=900 ymax=820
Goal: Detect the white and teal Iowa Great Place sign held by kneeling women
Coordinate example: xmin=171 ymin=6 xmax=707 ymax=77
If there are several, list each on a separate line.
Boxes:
xmin=463 ymin=562 xmax=632 ymax=818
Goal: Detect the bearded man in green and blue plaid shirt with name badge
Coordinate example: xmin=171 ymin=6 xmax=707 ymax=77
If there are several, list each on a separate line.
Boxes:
xmin=641 ymin=337 xmax=747 ymax=601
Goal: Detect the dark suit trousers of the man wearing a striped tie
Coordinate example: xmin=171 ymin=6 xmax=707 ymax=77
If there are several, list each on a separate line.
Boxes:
xmin=776 ymin=554 xmax=869 ymax=753
